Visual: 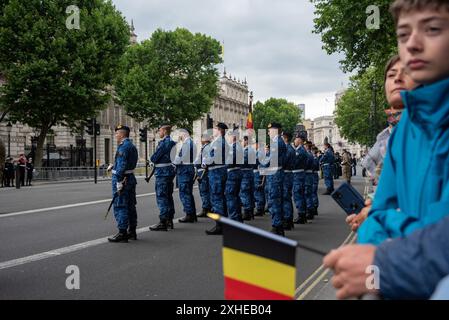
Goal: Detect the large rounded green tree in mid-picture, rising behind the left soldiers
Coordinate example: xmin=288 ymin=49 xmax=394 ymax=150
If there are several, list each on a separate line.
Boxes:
xmin=115 ymin=28 xmax=222 ymax=128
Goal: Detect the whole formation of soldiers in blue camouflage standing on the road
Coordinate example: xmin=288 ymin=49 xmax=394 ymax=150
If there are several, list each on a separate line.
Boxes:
xmin=109 ymin=123 xmax=334 ymax=242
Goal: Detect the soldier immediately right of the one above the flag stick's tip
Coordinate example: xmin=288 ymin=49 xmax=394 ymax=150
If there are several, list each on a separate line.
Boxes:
xmin=225 ymin=129 xmax=243 ymax=222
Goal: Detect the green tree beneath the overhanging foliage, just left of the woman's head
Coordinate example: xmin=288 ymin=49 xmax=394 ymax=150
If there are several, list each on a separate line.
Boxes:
xmin=334 ymin=68 xmax=387 ymax=146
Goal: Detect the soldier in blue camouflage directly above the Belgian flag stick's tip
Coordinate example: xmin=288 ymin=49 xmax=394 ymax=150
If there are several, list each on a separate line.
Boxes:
xmin=205 ymin=123 xmax=229 ymax=235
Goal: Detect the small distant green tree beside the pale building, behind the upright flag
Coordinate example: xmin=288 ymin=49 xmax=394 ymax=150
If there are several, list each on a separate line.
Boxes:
xmin=254 ymin=98 xmax=302 ymax=133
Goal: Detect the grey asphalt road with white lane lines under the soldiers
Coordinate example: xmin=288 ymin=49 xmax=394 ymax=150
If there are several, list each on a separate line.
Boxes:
xmin=0 ymin=177 xmax=364 ymax=300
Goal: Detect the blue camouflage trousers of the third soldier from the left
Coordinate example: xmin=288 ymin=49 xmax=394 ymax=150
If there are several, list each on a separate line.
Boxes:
xmin=176 ymin=165 xmax=196 ymax=216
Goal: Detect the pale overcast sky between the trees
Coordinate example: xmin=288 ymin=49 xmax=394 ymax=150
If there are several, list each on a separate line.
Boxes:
xmin=113 ymin=0 xmax=348 ymax=119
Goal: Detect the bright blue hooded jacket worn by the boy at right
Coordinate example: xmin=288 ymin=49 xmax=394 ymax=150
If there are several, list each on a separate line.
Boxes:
xmin=358 ymin=79 xmax=449 ymax=245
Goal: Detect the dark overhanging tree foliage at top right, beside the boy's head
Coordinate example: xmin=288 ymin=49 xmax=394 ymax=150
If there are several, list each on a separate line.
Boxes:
xmin=311 ymin=0 xmax=397 ymax=72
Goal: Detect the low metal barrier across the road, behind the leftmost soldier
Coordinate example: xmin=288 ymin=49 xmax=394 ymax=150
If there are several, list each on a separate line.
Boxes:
xmin=33 ymin=164 xmax=145 ymax=181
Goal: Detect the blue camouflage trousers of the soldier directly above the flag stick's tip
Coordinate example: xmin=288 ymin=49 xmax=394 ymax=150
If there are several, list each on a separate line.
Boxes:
xmin=208 ymin=167 xmax=228 ymax=217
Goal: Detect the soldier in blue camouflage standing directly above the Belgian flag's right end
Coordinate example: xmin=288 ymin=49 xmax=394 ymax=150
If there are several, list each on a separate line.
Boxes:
xmin=261 ymin=123 xmax=287 ymax=236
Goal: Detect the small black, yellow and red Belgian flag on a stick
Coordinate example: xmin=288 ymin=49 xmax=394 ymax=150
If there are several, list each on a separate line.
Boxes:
xmin=209 ymin=214 xmax=297 ymax=300
